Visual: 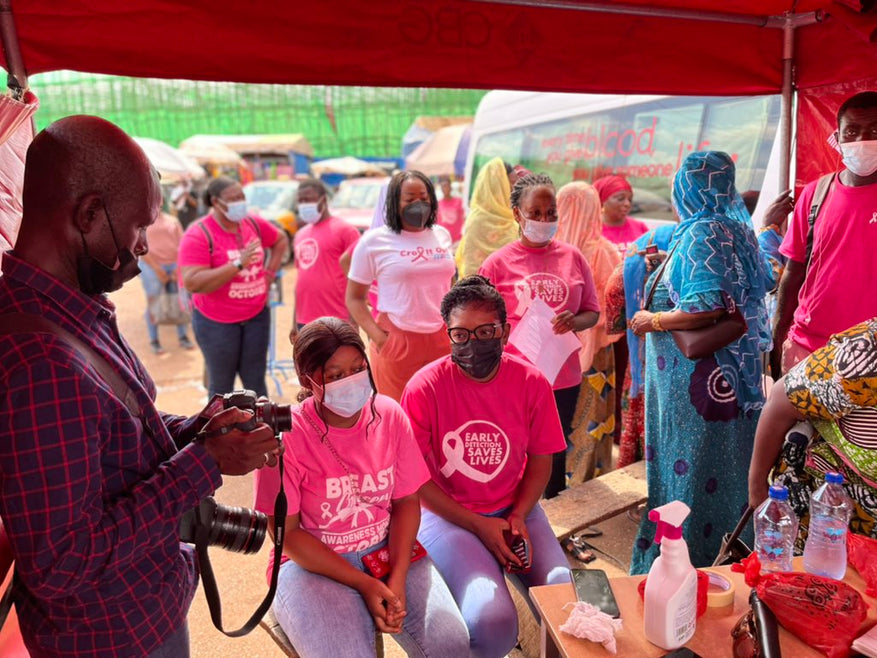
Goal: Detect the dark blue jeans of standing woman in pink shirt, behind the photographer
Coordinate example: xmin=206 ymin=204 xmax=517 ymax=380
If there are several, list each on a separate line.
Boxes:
xmin=192 ymin=306 xmax=271 ymax=397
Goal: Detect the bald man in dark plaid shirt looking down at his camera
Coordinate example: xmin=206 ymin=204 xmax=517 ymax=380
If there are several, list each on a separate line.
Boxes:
xmin=0 ymin=116 xmax=280 ymax=657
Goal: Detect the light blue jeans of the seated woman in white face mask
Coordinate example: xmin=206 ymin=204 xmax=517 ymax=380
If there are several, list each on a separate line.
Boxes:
xmin=274 ymin=546 xmax=469 ymax=658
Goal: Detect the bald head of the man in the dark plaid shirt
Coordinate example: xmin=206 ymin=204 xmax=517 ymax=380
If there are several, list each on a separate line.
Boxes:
xmin=15 ymin=116 xmax=161 ymax=287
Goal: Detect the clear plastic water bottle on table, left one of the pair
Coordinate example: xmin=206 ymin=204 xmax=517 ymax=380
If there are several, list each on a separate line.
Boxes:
xmin=755 ymin=485 xmax=798 ymax=571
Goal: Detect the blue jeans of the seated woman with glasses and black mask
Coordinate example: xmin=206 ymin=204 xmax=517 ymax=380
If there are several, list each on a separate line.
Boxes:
xmin=417 ymin=504 xmax=571 ymax=658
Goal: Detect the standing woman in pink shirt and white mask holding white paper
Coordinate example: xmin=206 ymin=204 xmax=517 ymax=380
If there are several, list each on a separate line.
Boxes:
xmin=478 ymin=174 xmax=611 ymax=498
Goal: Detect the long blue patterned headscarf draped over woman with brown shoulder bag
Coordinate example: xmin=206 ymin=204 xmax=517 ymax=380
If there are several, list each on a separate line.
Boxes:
xmin=664 ymin=151 xmax=773 ymax=412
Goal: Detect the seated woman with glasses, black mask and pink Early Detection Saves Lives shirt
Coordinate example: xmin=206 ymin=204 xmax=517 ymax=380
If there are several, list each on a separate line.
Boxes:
xmin=402 ymin=275 xmax=570 ymax=656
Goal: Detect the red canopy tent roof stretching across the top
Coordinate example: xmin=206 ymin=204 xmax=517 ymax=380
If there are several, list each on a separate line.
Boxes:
xmin=0 ymin=0 xmax=877 ymax=249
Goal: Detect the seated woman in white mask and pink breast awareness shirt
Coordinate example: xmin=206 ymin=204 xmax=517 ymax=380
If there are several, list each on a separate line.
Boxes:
xmin=256 ymin=317 xmax=469 ymax=658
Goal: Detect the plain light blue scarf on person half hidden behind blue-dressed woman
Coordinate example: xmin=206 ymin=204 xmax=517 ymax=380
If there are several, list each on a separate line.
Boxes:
xmin=616 ymin=224 xmax=676 ymax=398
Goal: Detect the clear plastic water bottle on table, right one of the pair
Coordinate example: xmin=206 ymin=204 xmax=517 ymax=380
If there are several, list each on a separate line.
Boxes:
xmin=804 ymin=472 xmax=852 ymax=580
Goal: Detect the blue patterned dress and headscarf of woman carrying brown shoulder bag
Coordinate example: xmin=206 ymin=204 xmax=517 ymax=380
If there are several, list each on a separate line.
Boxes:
xmin=630 ymin=152 xmax=779 ymax=574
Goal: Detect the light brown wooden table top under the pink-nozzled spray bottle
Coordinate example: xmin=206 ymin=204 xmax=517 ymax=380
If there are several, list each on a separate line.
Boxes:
xmin=530 ymin=564 xmax=877 ymax=658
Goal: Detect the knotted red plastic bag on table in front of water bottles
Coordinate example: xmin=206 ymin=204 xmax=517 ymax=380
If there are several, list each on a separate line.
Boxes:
xmin=731 ymin=553 xmax=868 ymax=658
